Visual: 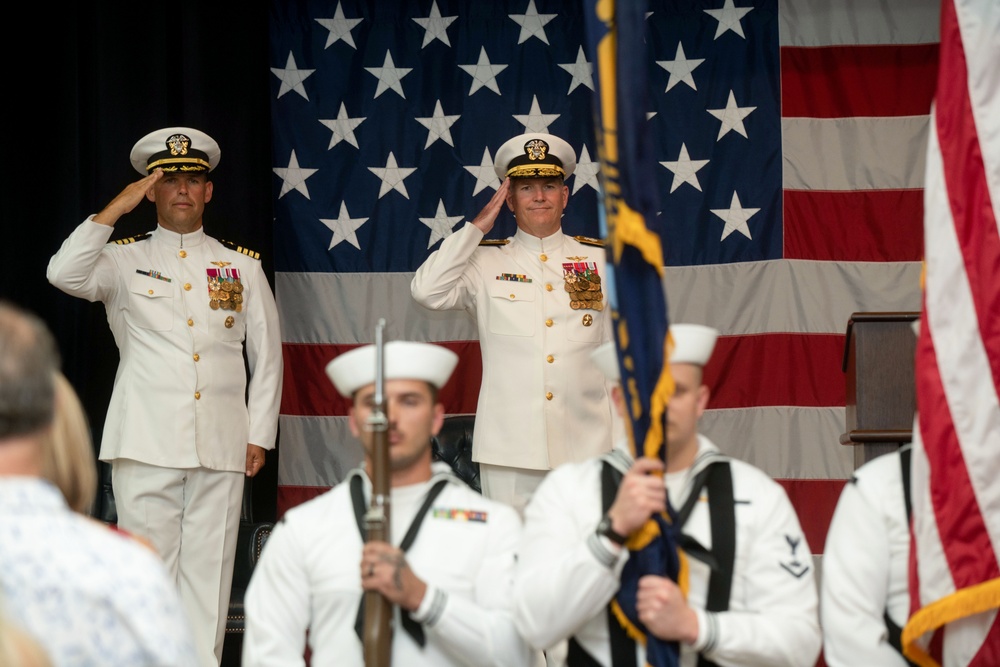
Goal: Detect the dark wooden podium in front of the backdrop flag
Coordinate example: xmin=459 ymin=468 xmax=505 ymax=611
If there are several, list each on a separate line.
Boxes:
xmin=840 ymin=312 xmax=920 ymax=469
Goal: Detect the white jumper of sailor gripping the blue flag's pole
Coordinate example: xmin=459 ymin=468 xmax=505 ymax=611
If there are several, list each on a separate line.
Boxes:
xmin=514 ymin=436 xmax=821 ymax=667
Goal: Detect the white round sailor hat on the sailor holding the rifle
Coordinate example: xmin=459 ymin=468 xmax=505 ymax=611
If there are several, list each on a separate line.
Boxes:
xmin=326 ymin=340 xmax=458 ymax=398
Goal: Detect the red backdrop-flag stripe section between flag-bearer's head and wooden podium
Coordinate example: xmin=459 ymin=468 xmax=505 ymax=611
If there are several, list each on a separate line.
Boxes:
xmin=705 ymin=334 xmax=847 ymax=409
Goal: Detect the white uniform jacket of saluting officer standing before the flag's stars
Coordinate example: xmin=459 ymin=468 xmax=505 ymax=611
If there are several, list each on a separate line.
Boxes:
xmin=410 ymin=223 xmax=613 ymax=470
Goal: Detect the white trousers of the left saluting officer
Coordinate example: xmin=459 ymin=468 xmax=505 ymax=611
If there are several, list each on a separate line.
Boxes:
xmin=112 ymin=459 xmax=245 ymax=667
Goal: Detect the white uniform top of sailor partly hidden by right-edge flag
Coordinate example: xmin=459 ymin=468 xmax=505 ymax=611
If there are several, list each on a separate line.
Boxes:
xmin=820 ymin=452 xmax=910 ymax=667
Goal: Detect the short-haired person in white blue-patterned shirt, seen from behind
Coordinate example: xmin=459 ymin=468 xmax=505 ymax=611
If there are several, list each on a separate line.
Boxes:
xmin=0 ymin=303 xmax=197 ymax=667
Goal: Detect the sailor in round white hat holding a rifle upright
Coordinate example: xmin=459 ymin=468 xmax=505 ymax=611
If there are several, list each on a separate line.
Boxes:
xmin=243 ymin=341 xmax=529 ymax=667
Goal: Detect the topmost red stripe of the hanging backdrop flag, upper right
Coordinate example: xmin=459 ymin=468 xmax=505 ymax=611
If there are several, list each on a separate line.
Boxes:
xmin=781 ymin=44 xmax=938 ymax=118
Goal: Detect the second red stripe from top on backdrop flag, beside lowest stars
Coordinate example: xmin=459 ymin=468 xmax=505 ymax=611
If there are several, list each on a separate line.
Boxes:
xmin=783 ymin=190 xmax=924 ymax=262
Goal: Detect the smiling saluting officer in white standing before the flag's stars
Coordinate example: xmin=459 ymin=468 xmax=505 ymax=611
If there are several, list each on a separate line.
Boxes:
xmin=410 ymin=132 xmax=617 ymax=511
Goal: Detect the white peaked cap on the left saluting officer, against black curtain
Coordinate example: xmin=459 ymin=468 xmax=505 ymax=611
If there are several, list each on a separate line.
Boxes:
xmin=129 ymin=127 xmax=222 ymax=175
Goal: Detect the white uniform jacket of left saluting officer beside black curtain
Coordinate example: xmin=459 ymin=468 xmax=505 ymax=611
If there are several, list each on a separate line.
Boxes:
xmin=47 ymin=218 xmax=282 ymax=472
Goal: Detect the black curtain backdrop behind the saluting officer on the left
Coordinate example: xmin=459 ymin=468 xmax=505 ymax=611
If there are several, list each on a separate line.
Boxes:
xmin=0 ymin=6 xmax=277 ymax=520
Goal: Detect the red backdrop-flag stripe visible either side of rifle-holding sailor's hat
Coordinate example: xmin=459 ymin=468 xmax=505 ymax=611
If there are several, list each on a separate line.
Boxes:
xmin=281 ymin=340 xmax=483 ymax=416
